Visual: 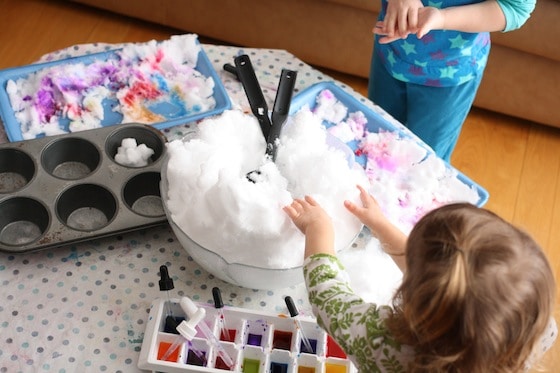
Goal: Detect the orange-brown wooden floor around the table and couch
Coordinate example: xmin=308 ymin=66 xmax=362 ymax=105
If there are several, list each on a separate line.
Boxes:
xmin=0 ymin=0 xmax=560 ymax=372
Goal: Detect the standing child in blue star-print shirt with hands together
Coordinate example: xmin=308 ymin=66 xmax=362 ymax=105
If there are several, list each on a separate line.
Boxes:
xmin=368 ymin=0 xmax=536 ymax=161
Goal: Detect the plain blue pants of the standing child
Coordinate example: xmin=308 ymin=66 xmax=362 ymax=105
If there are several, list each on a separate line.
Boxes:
xmin=368 ymin=51 xmax=482 ymax=162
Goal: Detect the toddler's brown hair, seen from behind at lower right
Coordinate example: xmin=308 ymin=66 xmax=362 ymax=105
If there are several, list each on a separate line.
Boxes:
xmin=388 ymin=203 xmax=555 ymax=372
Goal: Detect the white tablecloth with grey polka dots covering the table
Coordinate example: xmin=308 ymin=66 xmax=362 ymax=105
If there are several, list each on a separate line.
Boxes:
xmin=0 ymin=44 xmax=400 ymax=373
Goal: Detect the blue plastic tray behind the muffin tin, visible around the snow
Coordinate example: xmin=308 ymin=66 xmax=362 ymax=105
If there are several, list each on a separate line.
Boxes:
xmin=0 ymin=41 xmax=231 ymax=141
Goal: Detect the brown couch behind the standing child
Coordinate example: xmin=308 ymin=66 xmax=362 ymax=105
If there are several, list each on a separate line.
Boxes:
xmin=75 ymin=0 xmax=560 ymax=127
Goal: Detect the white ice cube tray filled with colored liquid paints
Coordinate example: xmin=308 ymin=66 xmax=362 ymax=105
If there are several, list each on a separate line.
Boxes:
xmin=138 ymin=299 xmax=357 ymax=373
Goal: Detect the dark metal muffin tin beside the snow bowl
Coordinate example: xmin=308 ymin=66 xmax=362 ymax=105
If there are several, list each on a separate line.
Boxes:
xmin=0 ymin=123 xmax=167 ymax=252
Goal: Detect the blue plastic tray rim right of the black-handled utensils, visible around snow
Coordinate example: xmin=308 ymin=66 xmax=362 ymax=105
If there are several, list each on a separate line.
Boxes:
xmin=290 ymin=82 xmax=489 ymax=207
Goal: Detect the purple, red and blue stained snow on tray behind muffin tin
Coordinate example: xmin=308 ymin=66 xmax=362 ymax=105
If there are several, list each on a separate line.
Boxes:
xmin=6 ymin=34 xmax=216 ymax=139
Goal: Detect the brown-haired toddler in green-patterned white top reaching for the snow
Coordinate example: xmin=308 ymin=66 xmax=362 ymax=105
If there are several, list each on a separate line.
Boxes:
xmin=284 ymin=187 xmax=557 ymax=373
